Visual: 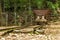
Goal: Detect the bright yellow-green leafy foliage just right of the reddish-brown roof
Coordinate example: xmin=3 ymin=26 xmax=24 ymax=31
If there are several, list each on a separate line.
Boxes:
xmin=47 ymin=1 xmax=59 ymax=17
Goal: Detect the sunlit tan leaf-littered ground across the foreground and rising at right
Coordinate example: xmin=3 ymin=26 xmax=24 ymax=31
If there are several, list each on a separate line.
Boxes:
xmin=0 ymin=22 xmax=60 ymax=40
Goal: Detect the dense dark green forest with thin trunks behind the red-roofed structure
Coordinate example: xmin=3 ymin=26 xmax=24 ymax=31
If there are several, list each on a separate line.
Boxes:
xmin=0 ymin=0 xmax=60 ymax=26
